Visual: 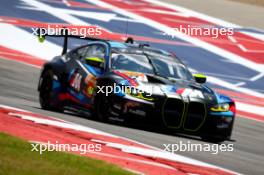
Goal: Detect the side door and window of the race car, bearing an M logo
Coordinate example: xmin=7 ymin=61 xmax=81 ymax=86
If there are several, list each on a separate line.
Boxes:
xmin=66 ymin=42 xmax=107 ymax=108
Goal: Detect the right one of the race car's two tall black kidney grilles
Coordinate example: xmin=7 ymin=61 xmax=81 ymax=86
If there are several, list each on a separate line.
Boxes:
xmin=184 ymin=102 xmax=206 ymax=131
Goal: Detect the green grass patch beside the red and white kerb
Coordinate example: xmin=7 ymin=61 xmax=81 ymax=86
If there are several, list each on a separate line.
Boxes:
xmin=0 ymin=133 xmax=133 ymax=175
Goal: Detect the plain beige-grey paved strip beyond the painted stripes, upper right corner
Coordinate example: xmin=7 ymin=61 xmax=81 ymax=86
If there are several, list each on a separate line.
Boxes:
xmin=164 ymin=0 xmax=264 ymax=30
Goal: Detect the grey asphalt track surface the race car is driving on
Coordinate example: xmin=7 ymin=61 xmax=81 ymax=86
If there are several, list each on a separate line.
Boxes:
xmin=0 ymin=59 xmax=264 ymax=174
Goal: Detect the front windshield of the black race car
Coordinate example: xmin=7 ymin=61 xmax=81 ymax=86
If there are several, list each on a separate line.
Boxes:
xmin=111 ymin=53 xmax=192 ymax=80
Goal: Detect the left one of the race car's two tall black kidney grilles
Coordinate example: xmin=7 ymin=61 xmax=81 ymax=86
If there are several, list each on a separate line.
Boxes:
xmin=163 ymin=98 xmax=184 ymax=128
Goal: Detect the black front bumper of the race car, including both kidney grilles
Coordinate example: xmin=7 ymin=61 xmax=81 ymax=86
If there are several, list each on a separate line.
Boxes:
xmin=110 ymin=93 xmax=234 ymax=137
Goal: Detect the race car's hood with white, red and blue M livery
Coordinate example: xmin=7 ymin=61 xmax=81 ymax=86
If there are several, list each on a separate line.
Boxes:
xmin=114 ymin=71 xmax=217 ymax=101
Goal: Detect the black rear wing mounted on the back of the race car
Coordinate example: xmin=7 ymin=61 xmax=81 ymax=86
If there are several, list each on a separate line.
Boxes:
xmin=35 ymin=27 xmax=134 ymax=55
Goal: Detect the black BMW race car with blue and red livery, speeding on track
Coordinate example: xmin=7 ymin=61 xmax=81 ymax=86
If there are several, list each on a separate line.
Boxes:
xmin=38 ymin=33 xmax=235 ymax=142
